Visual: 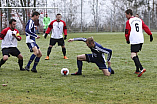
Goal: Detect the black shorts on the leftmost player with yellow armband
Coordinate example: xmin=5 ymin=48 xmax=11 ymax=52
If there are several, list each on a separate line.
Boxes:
xmin=2 ymin=47 xmax=21 ymax=57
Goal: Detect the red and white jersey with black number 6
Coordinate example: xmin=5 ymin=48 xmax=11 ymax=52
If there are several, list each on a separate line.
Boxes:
xmin=125 ymin=17 xmax=152 ymax=44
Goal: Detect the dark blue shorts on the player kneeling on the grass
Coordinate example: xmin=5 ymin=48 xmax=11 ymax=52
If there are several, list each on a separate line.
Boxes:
xmin=85 ymin=54 xmax=107 ymax=69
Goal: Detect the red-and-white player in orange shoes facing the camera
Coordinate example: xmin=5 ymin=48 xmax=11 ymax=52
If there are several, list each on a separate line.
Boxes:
xmin=44 ymin=14 xmax=68 ymax=60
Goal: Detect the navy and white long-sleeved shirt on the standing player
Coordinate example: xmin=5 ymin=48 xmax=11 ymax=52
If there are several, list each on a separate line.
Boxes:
xmin=25 ymin=19 xmax=38 ymax=43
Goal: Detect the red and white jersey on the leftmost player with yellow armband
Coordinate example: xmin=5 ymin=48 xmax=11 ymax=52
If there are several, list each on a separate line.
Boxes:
xmin=0 ymin=27 xmax=21 ymax=49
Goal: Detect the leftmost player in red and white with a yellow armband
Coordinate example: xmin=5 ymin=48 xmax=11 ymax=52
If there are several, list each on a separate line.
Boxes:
xmin=0 ymin=19 xmax=25 ymax=71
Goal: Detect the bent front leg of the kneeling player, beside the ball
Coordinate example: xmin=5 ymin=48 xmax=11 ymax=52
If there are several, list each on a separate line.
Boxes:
xmin=71 ymin=54 xmax=86 ymax=75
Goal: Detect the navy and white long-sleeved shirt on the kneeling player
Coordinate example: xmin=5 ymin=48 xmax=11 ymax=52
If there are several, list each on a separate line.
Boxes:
xmin=74 ymin=38 xmax=112 ymax=61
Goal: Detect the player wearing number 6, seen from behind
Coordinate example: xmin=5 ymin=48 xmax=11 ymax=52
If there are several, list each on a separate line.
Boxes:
xmin=125 ymin=9 xmax=153 ymax=77
